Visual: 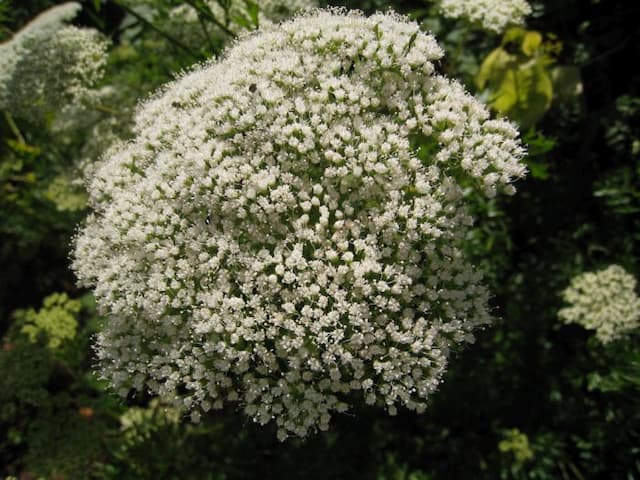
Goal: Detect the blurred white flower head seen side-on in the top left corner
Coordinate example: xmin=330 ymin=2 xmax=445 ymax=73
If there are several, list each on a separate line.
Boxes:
xmin=0 ymin=2 xmax=108 ymax=116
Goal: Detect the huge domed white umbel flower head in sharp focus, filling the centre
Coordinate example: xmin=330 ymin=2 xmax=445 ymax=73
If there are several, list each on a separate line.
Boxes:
xmin=74 ymin=10 xmax=525 ymax=438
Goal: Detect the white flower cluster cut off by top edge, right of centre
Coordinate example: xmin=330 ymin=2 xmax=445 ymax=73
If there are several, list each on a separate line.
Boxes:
xmin=440 ymin=0 xmax=531 ymax=33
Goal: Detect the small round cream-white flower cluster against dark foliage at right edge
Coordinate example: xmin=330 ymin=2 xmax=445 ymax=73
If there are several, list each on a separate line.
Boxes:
xmin=558 ymin=265 xmax=640 ymax=343
